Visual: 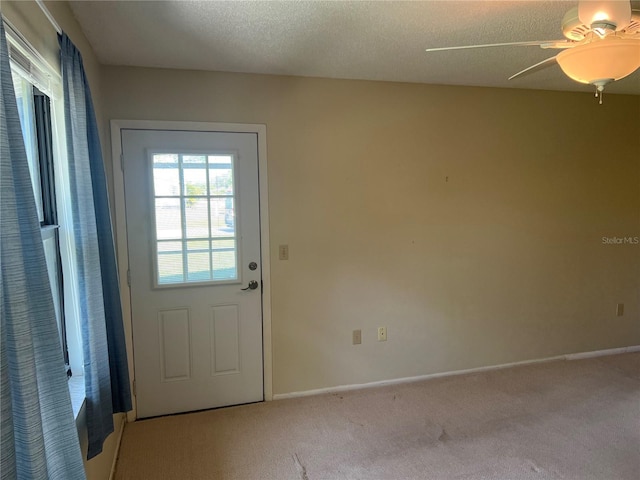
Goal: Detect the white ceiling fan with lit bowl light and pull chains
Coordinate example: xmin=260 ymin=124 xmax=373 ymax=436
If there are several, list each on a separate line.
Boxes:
xmin=427 ymin=0 xmax=640 ymax=104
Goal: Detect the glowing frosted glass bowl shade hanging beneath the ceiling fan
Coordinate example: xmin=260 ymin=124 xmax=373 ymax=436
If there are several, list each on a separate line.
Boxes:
xmin=556 ymin=35 xmax=640 ymax=87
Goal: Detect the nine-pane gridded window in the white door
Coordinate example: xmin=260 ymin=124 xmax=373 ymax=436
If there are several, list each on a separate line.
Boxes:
xmin=151 ymin=152 xmax=238 ymax=287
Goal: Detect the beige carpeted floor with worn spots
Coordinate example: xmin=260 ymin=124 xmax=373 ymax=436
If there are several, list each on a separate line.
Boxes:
xmin=115 ymin=353 xmax=640 ymax=480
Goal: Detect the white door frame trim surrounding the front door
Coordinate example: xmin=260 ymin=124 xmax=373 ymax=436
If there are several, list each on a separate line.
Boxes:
xmin=110 ymin=120 xmax=273 ymax=422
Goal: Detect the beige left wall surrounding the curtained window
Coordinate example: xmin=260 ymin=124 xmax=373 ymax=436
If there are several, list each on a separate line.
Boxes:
xmin=0 ymin=0 xmax=124 ymax=480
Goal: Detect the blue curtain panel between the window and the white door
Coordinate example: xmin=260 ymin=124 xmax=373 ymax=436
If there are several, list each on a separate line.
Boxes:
xmin=58 ymin=33 xmax=131 ymax=459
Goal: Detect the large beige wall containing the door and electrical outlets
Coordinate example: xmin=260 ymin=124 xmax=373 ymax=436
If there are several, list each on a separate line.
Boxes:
xmin=103 ymin=67 xmax=640 ymax=394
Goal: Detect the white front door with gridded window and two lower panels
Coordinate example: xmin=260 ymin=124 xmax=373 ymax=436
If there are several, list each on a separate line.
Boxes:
xmin=121 ymin=129 xmax=264 ymax=418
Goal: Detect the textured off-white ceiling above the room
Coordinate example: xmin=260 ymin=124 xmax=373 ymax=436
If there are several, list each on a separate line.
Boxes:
xmin=69 ymin=1 xmax=640 ymax=95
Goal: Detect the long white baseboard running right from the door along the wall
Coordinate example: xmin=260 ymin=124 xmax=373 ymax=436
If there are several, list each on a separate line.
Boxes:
xmin=273 ymin=345 xmax=640 ymax=400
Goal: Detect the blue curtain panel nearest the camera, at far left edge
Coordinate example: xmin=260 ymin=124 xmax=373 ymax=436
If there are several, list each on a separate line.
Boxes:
xmin=0 ymin=16 xmax=85 ymax=480
